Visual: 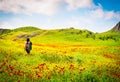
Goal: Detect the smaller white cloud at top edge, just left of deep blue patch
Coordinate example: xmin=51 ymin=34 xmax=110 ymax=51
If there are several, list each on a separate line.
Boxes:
xmin=65 ymin=0 xmax=94 ymax=10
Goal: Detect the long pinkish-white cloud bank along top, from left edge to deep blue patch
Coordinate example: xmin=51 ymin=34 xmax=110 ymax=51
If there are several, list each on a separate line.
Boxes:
xmin=0 ymin=0 xmax=94 ymax=15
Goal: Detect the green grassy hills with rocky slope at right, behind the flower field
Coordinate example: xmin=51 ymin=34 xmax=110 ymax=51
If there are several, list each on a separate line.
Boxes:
xmin=0 ymin=22 xmax=120 ymax=45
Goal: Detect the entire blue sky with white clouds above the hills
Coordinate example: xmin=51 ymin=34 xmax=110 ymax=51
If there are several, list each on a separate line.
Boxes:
xmin=0 ymin=0 xmax=120 ymax=32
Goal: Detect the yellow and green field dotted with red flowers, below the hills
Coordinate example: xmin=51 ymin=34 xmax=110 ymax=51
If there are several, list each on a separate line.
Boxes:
xmin=0 ymin=39 xmax=120 ymax=82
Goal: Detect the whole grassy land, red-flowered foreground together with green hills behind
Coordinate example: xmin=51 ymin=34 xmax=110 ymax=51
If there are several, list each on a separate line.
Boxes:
xmin=0 ymin=28 xmax=120 ymax=82
